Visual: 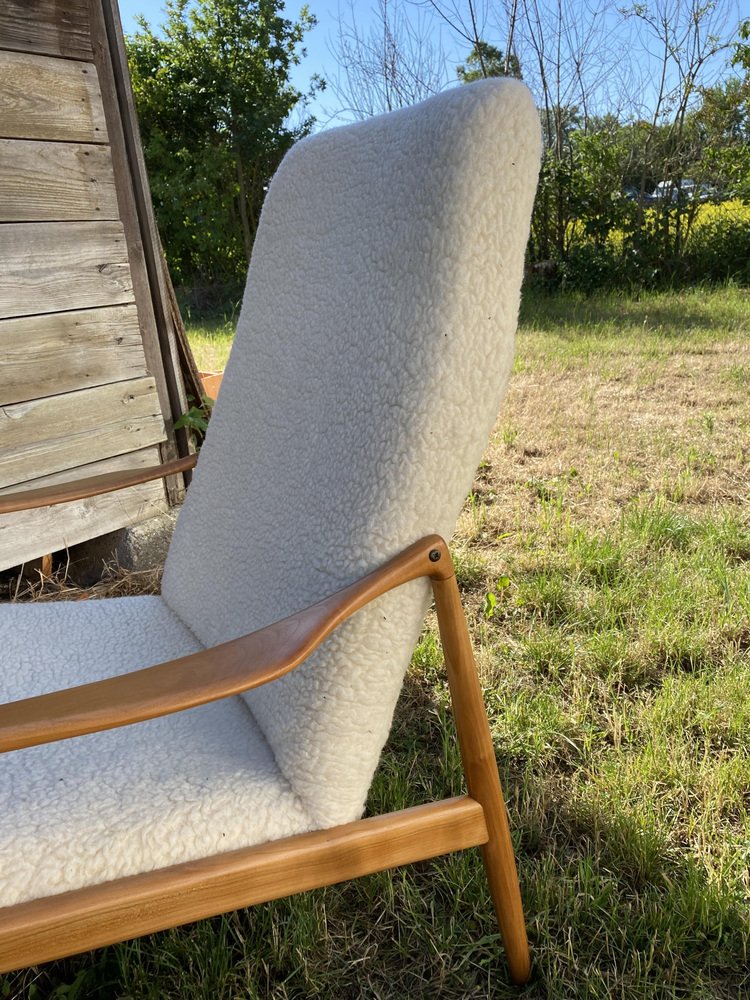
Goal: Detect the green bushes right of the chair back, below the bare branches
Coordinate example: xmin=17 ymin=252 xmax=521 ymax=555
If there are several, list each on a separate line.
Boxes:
xmin=529 ymin=80 xmax=750 ymax=292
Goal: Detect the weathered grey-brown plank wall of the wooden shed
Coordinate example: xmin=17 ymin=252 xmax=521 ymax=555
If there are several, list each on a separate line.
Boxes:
xmin=0 ymin=0 xmax=191 ymax=569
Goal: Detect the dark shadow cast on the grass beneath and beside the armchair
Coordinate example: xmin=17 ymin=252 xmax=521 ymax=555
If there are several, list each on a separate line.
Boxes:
xmin=0 ymin=676 xmax=750 ymax=1000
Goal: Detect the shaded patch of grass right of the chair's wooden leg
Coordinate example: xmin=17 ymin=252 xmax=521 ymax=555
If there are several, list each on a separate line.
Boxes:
xmin=519 ymin=787 xmax=750 ymax=1000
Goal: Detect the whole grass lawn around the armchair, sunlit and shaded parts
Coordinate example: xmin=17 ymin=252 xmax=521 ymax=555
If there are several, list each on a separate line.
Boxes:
xmin=0 ymin=289 xmax=750 ymax=1000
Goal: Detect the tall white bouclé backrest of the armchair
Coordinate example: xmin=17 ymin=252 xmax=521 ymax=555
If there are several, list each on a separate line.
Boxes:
xmin=163 ymin=80 xmax=540 ymax=825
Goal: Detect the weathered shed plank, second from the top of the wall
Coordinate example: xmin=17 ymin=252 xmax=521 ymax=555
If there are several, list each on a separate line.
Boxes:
xmin=0 ymin=51 xmax=108 ymax=142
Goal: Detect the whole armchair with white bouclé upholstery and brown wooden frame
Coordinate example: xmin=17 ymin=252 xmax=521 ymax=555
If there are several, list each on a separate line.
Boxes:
xmin=0 ymin=80 xmax=540 ymax=983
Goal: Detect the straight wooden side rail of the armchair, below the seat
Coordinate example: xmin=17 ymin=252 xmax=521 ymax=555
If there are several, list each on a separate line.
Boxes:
xmin=0 ymin=796 xmax=487 ymax=972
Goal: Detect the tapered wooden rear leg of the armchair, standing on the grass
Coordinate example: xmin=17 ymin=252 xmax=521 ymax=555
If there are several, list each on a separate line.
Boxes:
xmin=432 ymin=576 xmax=531 ymax=985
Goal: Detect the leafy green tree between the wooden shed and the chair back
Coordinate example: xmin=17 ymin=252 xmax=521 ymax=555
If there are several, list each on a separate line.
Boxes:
xmin=127 ymin=0 xmax=322 ymax=290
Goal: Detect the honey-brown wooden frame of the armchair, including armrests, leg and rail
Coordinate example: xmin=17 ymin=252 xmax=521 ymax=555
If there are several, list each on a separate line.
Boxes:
xmin=0 ymin=456 xmax=530 ymax=984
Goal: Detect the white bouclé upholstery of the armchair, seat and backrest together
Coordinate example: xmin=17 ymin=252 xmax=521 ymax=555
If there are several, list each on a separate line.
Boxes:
xmin=0 ymin=80 xmax=540 ymax=905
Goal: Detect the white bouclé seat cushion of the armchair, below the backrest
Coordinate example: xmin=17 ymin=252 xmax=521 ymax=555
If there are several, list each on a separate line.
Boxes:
xmin=0 ymin=597 xmax=312 ymax=906
